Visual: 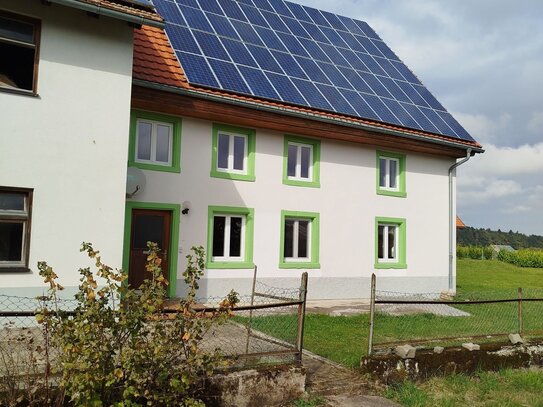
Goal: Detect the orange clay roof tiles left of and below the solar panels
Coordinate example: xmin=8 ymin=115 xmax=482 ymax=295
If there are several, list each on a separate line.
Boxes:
xmin=133 ymin=26 xmax=483 ymax=152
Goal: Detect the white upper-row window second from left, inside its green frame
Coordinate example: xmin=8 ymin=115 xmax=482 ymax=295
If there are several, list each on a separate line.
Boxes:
xmin=217 ymin=132 xmax=247 ymax=174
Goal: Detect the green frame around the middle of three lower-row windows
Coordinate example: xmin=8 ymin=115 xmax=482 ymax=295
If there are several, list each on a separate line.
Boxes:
xmin=279 ymin=210 xmax=321 ymax=269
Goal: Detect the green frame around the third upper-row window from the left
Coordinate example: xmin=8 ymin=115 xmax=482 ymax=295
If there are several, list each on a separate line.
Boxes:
xmin=283 ymin=135 xmax=321 ymax=188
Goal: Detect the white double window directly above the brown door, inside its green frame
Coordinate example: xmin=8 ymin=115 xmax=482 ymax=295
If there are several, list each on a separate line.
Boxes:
xmin=136 ymin=119 xmax=173 ymax=166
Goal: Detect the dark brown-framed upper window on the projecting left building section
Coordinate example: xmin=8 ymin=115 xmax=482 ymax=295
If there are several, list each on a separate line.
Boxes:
xmin=0 ymin=12 xmax=40 ymax=94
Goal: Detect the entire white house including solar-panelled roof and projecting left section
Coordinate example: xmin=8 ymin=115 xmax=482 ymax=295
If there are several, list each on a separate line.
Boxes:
xmin=0 ymin=0 xmax=483 ymax=299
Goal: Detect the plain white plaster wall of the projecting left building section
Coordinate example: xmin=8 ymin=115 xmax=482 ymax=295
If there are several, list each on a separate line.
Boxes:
xmin=0 ymin=0 xmax=132 ymax=293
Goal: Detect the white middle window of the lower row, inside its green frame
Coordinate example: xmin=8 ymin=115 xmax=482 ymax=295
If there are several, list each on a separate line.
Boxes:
xmin=283 ymin=218 xmax=311 ymax=262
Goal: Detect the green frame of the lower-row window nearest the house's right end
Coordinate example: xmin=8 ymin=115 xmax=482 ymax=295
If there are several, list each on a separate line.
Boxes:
xmin=374 ymin=217 xmax=407 ymax=269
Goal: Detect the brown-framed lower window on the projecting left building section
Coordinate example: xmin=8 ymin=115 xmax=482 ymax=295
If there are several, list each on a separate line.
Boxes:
xmin=0 ymin=188 xmax=32 ymax=271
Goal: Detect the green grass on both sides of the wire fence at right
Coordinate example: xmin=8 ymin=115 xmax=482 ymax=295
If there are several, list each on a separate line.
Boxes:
xmin=246 ymin=259 xmax=543 ymax=407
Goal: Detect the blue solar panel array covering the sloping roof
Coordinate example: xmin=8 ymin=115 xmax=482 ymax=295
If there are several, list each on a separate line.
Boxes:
xmin=153 ymin=0 xmax=473 ymax=141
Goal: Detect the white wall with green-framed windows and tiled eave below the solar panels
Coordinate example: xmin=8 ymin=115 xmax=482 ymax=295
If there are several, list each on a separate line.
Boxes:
xmin=127 ymin=7 xmax=482 ymax=299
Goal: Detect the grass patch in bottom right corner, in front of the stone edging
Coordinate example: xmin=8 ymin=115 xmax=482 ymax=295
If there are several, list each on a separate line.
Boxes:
xmin=385 ymin=369 xmax=543 ymax=407
